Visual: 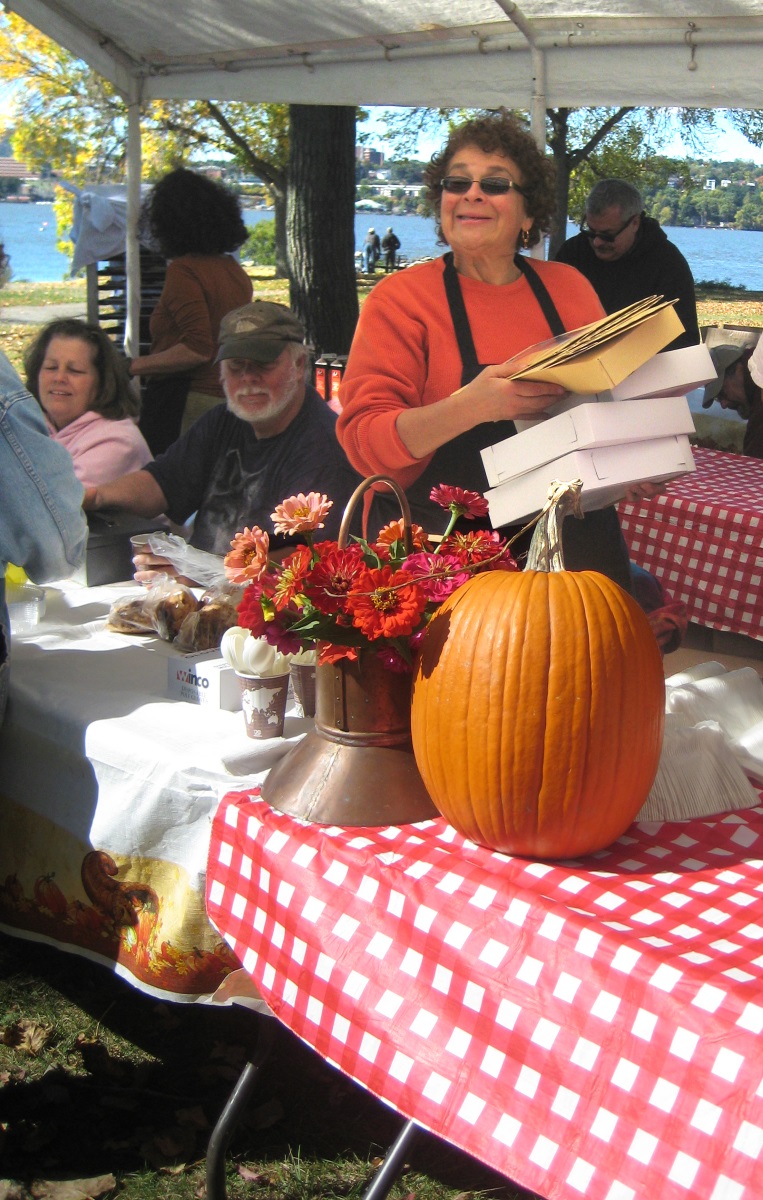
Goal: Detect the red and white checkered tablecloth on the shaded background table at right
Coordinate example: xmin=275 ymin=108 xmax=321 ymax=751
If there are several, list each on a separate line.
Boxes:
xmin=619 ymin=448 xmax=763 ymax=643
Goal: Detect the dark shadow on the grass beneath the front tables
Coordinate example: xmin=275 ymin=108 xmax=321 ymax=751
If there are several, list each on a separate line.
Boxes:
xmin=0 ymin=935 xmax=539 ymax=1200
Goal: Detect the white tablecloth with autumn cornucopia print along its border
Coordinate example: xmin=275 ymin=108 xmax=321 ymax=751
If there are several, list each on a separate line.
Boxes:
xmin=0 ymin=582 xmax=312 ymax=1000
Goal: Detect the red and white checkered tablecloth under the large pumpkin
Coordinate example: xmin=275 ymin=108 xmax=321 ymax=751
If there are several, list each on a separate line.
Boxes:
xmin=208 ymin=792 xmax=763 ymax=1200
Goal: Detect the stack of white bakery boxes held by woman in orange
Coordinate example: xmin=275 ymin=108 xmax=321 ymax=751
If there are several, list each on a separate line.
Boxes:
xmin=482 ymin=333 xmax=715 ymax=528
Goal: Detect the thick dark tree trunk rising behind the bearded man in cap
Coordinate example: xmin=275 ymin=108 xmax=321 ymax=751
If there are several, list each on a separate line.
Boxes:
xmin=287 ymin=104 xmax=359 ymax=354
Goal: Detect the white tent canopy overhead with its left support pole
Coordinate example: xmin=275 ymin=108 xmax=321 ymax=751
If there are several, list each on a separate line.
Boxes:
xmin=10 ymin=0 xmax=763 ymax=348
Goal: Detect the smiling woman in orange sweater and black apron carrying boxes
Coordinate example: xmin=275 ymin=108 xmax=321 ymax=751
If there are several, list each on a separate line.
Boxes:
xmin=337 ymin=110 xmax=655 ymax=592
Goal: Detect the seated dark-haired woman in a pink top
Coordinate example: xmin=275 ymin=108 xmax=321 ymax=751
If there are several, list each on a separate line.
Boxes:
xmin=24 ymin=318 xmax=152 ymax=487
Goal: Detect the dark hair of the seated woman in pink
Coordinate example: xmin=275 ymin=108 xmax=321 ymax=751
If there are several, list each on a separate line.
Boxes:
xmin=24 ymin=317 xmax=140 ymax=421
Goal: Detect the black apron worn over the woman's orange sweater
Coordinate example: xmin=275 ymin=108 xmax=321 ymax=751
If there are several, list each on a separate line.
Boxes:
xmin=368 ymin=252 xmax=631 ymax=592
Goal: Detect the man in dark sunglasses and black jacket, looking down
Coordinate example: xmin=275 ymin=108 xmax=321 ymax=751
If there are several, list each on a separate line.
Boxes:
xmin=557 ymin=179 xmax=699 ymax=350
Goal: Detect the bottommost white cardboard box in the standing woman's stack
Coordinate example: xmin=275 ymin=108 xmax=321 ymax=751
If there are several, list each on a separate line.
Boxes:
xmin=485 ymin=434 xmax=695 ymax=529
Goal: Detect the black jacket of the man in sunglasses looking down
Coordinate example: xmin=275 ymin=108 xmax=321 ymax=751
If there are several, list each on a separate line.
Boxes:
xmin=557 ymin=217 xmax=701 ymax=350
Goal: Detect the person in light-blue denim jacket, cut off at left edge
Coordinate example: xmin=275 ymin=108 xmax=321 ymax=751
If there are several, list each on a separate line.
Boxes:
xmin=0 ymin=244 xmax=88 ymax=722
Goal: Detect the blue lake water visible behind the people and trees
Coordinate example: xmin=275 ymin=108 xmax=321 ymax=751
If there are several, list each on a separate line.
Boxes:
xmin=0 ymin=202 xmax=763 ymax=292
